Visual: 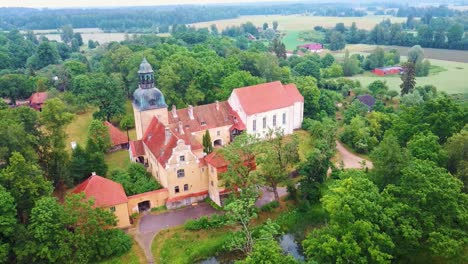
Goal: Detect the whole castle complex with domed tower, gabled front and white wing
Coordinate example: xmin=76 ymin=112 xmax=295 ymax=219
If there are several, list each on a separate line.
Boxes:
xmin=129 ymin=59 xmax=304 ymax=208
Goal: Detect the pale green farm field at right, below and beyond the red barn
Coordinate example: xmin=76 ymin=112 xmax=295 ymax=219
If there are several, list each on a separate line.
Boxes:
xmin=349 ymin=58 xmax=468 ymax=94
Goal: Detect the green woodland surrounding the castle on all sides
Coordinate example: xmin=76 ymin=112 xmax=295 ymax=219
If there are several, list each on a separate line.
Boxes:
xmin=0 ymin=2 xmax=468 ymax=263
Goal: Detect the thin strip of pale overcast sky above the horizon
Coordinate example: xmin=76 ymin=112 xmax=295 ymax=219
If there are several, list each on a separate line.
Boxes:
xmin=0 ymin=0 xmax=291 ymax=8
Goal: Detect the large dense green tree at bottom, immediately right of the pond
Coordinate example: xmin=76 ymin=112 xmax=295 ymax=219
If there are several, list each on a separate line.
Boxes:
xmin=303 ymin=171 xmax=394 ymax=263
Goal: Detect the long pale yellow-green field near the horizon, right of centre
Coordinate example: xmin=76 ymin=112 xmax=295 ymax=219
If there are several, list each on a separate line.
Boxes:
xmin=191 ymin=15 xmax=406 ymax=31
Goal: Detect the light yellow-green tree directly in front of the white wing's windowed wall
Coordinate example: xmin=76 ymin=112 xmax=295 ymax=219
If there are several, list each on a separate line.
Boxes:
xmin=257 ymin=129 xmax=299 ymax=201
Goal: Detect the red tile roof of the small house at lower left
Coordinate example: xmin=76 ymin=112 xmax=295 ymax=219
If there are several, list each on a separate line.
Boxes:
xmin=72 ymin=175 xmax=128 ymax=207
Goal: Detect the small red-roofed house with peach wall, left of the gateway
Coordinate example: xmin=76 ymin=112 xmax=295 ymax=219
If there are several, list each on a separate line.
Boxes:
xmin=72 ymin=173 xmax=130 ymax=228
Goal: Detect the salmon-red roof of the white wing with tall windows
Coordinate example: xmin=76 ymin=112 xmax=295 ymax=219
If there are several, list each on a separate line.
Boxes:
xmin=233 ymin=81 xmax=304 ymax=115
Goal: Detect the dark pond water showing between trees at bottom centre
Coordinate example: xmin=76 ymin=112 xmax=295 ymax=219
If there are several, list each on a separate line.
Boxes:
xmin=199 ymin=233 xmax=304 ymax=264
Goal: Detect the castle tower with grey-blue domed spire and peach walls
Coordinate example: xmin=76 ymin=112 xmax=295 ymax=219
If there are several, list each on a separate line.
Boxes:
xmin=133 ymin=58 xmax=168 ymax=139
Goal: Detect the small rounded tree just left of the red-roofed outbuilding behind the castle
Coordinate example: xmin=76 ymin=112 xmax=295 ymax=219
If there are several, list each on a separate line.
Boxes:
xmin=86 ymin=119 xmax=112 ymax=153
